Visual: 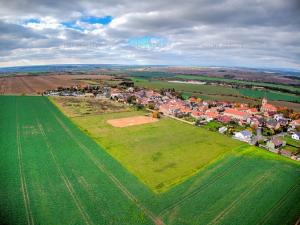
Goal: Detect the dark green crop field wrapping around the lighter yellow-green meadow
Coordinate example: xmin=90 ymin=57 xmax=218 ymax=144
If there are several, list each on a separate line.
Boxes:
xmin=0 ymin=96 xmax=300 ymax=225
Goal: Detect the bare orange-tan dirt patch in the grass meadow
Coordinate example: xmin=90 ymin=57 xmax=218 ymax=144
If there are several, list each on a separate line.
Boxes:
xmin=107 ymin=116 xmax=158 ymax=127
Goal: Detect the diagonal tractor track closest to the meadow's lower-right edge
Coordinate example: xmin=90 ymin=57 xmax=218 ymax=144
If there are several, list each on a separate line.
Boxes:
xmin=159 ymin=156 xmax=243 ymax=217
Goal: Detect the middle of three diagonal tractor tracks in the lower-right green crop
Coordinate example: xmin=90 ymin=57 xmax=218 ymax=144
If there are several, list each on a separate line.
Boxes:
xmin=208 ymin=171 xmax=271 ymax=225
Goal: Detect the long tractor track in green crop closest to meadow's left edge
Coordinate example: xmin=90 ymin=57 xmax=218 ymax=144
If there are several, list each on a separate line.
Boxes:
xmin=51 ymin=107 xmax=165 ymax=225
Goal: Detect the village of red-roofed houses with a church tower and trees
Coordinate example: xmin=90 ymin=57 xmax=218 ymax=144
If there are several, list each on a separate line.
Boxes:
xmin=43 ymin=82 xmax=300 ymax=161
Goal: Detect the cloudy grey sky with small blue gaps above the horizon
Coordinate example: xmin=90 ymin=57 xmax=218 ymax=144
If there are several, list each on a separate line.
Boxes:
xmin=0 ymin=0 xmax=300 ymax=69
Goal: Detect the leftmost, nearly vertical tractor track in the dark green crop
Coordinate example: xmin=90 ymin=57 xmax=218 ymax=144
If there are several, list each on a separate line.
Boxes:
xmin=16 ymin=102 xmax=34 ymax=225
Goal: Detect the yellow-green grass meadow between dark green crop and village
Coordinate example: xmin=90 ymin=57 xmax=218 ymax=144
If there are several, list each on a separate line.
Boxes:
xmin=68 ymin=111 xmax=244 ymax=192
